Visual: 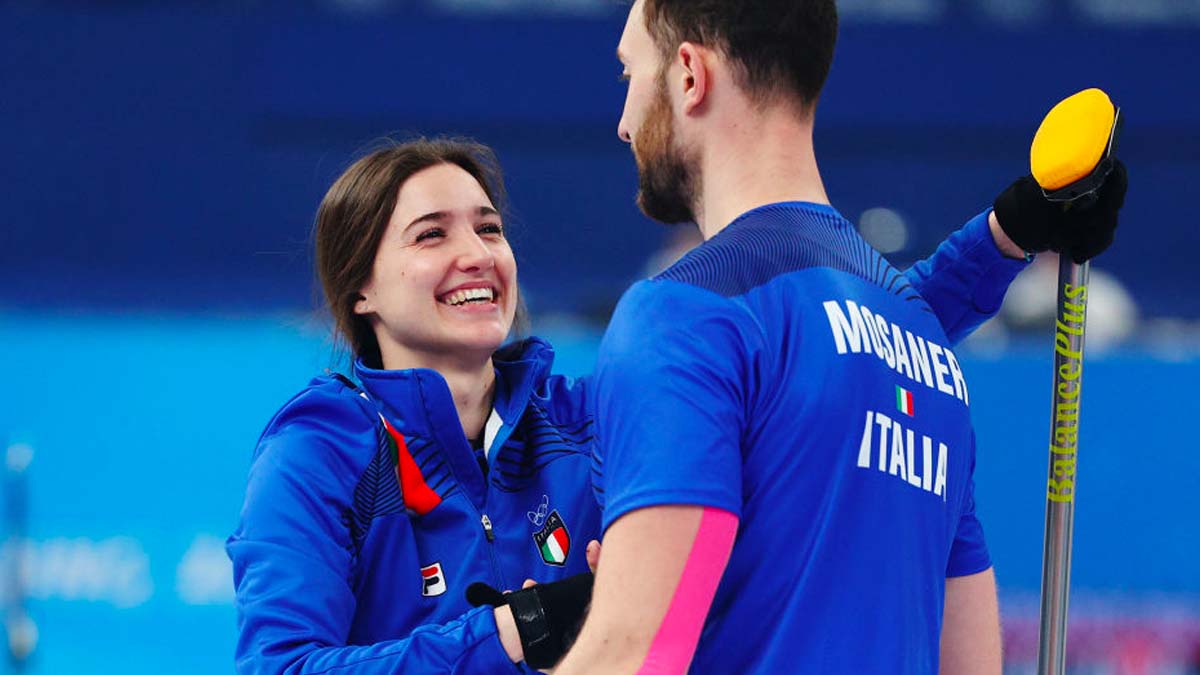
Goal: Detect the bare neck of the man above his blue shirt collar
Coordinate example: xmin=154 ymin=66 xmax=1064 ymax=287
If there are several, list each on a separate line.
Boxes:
xmin=696 ymin=106 xmax=829 ymax=239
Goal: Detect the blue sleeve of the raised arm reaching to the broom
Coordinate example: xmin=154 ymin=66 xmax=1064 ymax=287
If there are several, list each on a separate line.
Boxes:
xmin=905 ymin=209 xmax=1030 ymax=345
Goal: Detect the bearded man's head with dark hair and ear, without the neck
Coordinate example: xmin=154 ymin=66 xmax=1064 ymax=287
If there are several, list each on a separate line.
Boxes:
xmin=617 ymin=0 xmax=838 ymax=222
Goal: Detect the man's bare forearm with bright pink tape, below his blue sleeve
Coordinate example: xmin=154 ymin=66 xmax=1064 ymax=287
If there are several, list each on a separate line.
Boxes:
xmin=554 ymin=506 xmax=738 ymax=675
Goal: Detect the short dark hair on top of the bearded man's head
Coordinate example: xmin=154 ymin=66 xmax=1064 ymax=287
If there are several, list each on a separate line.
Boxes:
xmin=644 ymin=0 xmax=838 ymax=108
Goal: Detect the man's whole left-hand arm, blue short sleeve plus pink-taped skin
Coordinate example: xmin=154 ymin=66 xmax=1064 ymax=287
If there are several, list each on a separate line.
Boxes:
xmin=558 ymin=280 xmax=748 ymax=674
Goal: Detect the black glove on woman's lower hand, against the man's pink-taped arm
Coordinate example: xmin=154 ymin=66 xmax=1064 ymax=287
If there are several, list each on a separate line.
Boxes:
xmin=467 ymin=572 xmax=593 ymax=669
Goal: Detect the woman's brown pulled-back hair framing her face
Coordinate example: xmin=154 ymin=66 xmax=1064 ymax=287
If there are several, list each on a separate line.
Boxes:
xmin=314 ymin=138 xmax=511 ymax=368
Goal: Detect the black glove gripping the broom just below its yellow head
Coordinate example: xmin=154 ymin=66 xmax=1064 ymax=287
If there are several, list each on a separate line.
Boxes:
xmin=994 ymin=159 xmax=1128 ymax=263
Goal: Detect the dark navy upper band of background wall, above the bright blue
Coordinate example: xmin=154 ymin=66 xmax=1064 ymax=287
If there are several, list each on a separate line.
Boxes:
xmin=0 ymin=2 xmax=1200 ymax=317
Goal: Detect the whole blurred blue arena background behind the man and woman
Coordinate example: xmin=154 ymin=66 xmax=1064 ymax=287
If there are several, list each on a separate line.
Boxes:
xmin=0 ymin=0 xmax=1200 ymax=675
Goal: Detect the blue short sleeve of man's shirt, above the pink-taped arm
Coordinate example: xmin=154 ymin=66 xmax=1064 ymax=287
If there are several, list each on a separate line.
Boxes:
xmin=594 ymin=281 xmax=761 ymax=530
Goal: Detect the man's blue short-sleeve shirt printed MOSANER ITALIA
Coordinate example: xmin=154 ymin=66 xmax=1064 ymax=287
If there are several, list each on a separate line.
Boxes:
xmin=594 ymin=203 xmax=990 ymax=674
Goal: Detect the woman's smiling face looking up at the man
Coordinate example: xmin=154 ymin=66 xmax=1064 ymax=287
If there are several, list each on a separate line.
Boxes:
xmin=354 ymin=165 xmax=517 ymax=369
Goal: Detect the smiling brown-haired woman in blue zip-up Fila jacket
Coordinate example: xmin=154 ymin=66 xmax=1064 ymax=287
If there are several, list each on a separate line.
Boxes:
xmin=228 ymin=141 xmax=1015 ymax=673
